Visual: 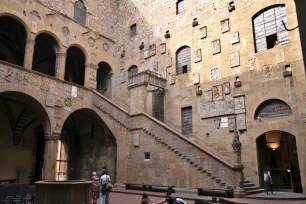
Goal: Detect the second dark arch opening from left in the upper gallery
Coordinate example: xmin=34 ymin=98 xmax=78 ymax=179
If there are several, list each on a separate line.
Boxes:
xmin=32 ymin=33 xmax=58 ymax=76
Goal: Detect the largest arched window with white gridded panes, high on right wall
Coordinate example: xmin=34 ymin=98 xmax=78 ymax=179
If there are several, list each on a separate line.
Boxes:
xmin=253 ymin=5 xmax=289 ymax=52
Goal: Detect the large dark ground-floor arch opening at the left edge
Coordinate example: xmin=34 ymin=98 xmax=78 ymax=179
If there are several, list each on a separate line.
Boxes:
xmin=0 ymin=92 xmax=51 ymax=183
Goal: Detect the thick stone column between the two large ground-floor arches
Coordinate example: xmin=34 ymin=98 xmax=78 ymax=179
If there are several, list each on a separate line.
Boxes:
xmin=43 ymin=133 xmax=60 ymax=181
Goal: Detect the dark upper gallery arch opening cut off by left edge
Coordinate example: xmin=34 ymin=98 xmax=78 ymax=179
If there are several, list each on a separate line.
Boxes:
xmin=0 ymin=16 xmax=27 ymax=66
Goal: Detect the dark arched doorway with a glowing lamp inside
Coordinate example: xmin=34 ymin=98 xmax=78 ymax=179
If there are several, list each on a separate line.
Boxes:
xmin=256 ymin=130 xmax=302 ymax=192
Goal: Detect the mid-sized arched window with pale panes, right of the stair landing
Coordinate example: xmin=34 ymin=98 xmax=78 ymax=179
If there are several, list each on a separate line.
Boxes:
xmin=176 ymin=46 xmax=191 ymax=75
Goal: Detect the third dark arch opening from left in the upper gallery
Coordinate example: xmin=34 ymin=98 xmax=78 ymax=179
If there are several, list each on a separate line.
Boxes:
xmin=65 ymin=46 xmax=86 ymax=86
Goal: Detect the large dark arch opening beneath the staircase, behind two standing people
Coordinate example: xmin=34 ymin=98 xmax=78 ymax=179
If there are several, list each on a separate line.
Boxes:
xmin=56 ymin=109 xmax=117 ymax=182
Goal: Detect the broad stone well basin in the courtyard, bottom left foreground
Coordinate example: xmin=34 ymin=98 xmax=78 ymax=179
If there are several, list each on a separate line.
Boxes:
xmin=35 ymin=180 xmax=92 ymax=204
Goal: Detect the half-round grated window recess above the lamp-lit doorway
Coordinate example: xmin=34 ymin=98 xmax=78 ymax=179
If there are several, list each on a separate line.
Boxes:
xmin=254 ymin=99 xmax=293 ymax=120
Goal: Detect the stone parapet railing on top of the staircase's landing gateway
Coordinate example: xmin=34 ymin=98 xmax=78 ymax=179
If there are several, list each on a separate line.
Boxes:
xmin=129 ymin=70 xmax=167 ymax=89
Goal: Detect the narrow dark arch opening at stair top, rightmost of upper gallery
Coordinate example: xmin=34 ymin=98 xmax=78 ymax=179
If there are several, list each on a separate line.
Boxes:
xmin=97 ymin=62 xmax=112 ymax=99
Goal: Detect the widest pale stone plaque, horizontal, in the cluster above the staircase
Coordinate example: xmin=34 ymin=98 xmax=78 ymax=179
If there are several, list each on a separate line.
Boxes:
xmin=200 ymin=100 xmax=235 ymax=119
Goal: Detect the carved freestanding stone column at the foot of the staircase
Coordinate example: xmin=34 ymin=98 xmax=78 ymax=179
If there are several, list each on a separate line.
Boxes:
xmin=232 ymin=132 xmax=247 ymax=198
